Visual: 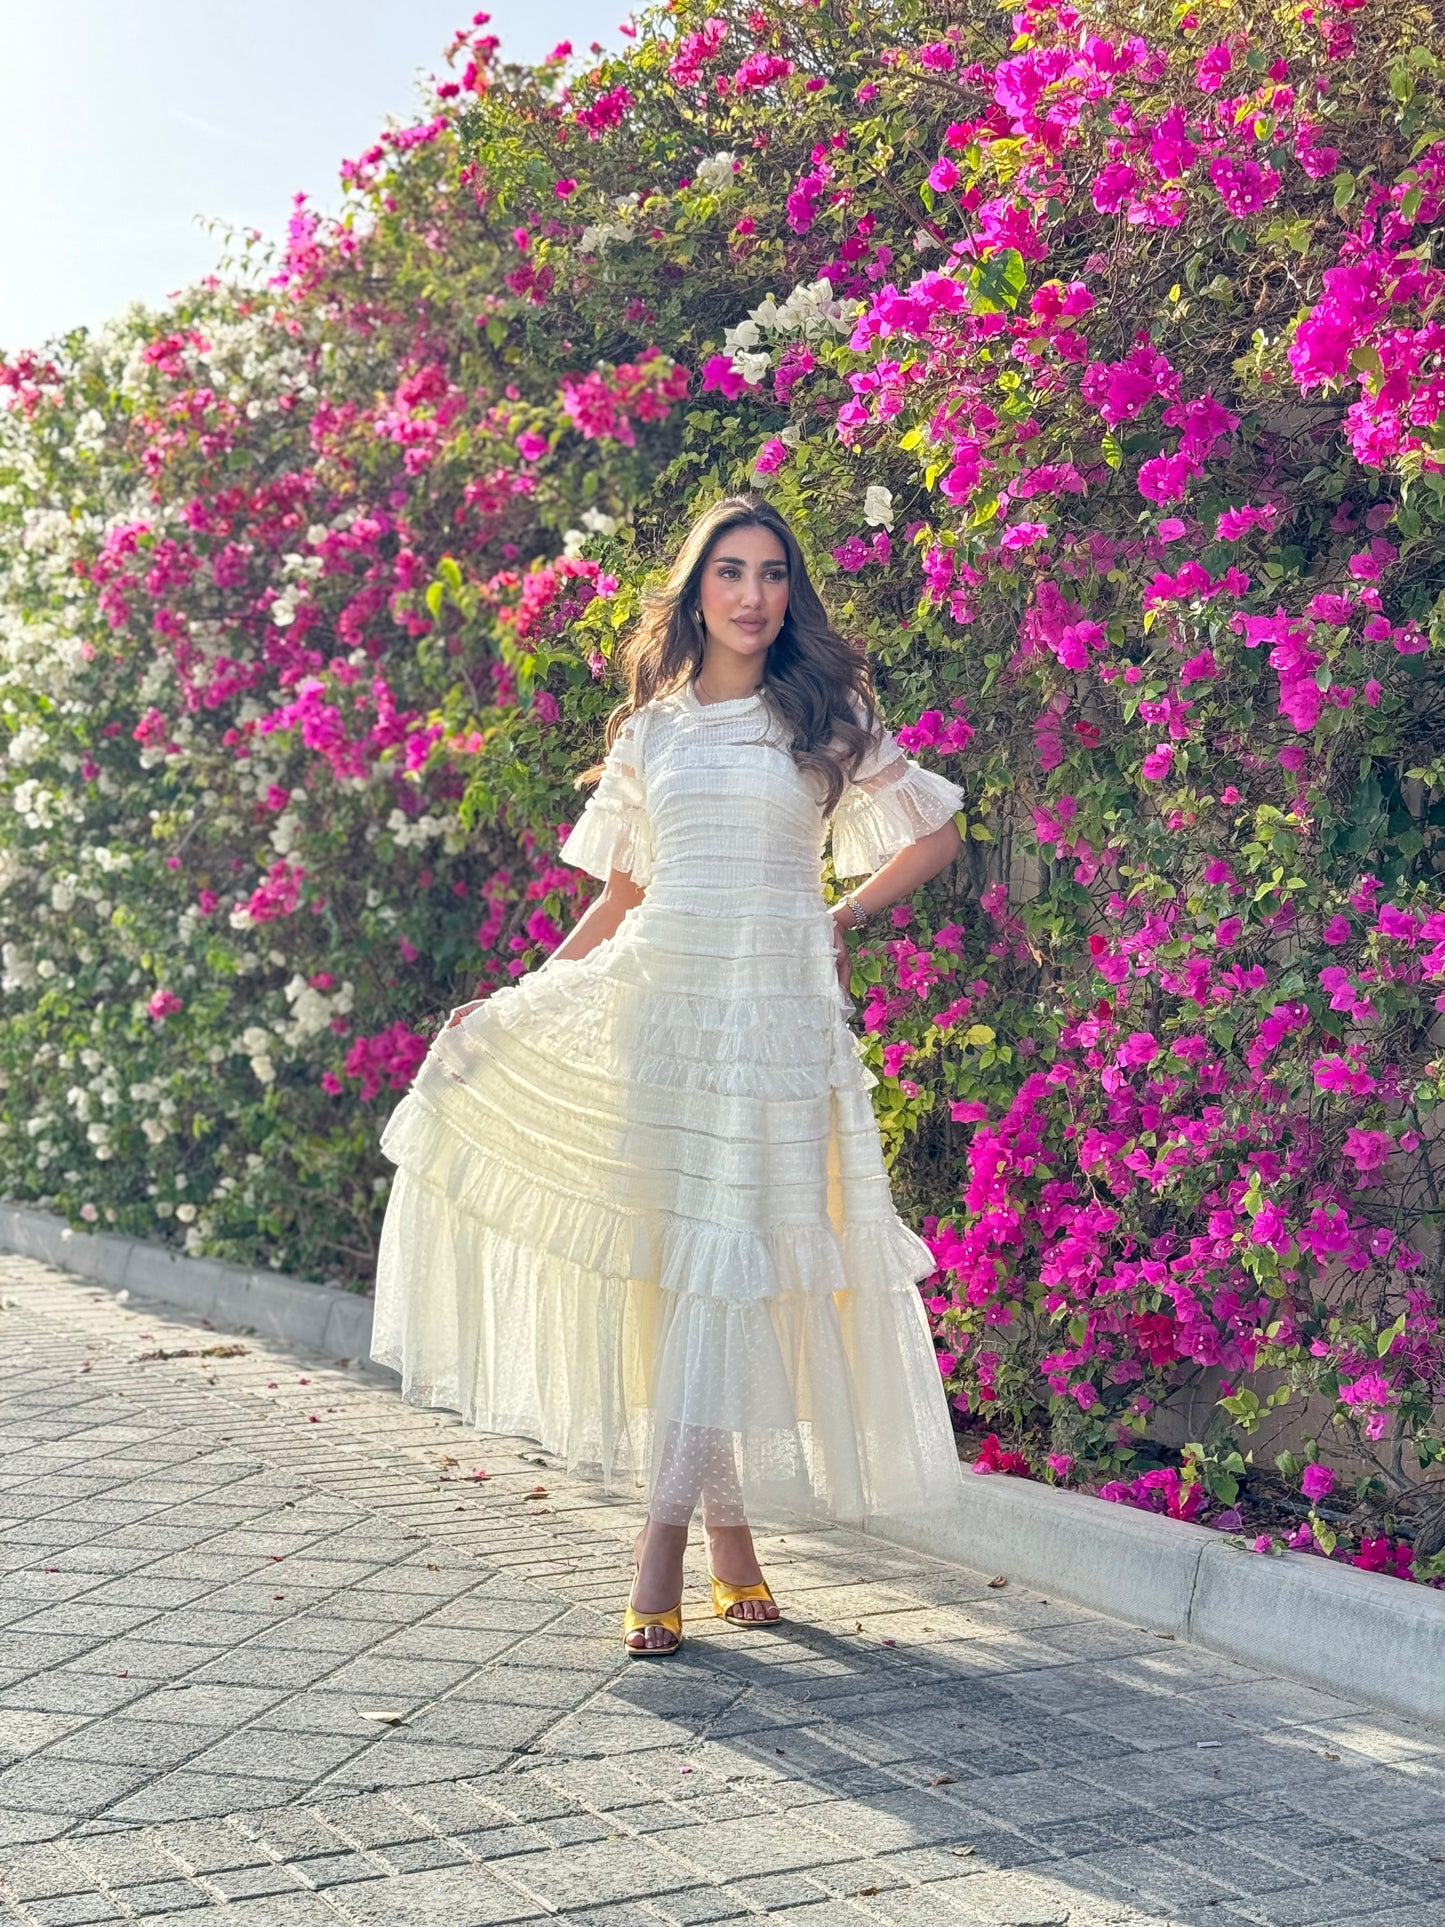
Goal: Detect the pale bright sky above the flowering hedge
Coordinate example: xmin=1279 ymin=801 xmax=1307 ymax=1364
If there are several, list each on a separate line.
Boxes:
xmin=0 ymin=0 xmax=630 ymax=353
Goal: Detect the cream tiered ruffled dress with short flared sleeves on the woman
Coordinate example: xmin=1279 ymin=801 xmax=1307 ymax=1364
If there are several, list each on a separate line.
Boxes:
xmin=372 ymin=686 xmax=963 ymax=1524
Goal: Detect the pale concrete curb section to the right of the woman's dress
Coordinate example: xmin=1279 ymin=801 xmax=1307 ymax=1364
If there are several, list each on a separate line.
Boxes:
xmin=869 ymin=1470 xmax=1445 ymax=1723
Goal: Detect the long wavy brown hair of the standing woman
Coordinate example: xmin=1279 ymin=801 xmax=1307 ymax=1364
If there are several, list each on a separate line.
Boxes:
xmin=576 ymin=495 xmax=877 ymax=811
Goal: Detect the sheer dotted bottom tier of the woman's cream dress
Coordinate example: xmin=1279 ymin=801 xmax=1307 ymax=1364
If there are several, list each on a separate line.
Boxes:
xmin=372 ymin=1170 xmax=959 ymax=1522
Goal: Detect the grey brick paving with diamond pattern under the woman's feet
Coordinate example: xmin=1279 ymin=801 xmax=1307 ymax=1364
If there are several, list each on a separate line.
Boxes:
xmin=0 ymin=1254 xmax=1445 ymax=1927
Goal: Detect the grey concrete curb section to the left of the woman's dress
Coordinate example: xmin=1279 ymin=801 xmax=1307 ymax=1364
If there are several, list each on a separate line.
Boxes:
xmin=0 ymin=1204 xmax=372 ymax=1359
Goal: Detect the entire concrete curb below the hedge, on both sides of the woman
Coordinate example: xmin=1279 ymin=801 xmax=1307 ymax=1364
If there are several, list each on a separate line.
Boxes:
xmin=0 ymin=1204 xmax=1445 ymax=1723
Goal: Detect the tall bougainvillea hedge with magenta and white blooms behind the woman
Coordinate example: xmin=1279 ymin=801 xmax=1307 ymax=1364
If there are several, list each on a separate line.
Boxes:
xmin=0 ymin=0 xmax=1445 ymax=1578
